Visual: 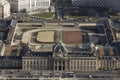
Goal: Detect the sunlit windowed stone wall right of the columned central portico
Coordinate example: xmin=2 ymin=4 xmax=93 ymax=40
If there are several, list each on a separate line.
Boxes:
xmin=70 ymin=57 xmax=98 ymax=72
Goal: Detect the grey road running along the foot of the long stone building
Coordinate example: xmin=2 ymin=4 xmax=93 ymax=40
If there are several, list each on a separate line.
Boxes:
xmin=0 ymin=71 xmax=120 ymax=80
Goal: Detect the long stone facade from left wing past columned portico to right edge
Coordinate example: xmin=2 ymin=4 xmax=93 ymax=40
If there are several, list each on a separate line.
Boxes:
xmin=22 ymin=53 xmax=120 ymax=72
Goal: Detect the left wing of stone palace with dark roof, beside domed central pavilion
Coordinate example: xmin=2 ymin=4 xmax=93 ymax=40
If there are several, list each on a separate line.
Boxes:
xmin=22 ymin=52 xmax=53 ymax=71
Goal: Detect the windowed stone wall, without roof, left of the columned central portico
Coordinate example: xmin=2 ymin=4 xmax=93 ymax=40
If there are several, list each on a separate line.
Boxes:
xmin=22 ymin=56 xmax=53 ymax=71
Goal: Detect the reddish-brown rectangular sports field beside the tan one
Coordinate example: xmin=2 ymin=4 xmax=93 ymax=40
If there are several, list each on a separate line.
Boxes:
xmin=63 ymin=31 xmax=82 ymax=44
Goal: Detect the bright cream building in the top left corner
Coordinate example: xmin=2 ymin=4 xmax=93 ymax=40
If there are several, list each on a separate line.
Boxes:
xmin=0 ymin=0 xmax=10 ymax=19
